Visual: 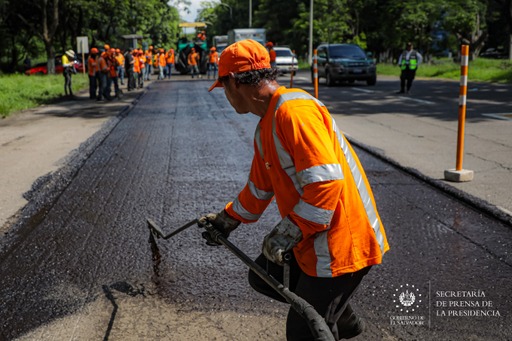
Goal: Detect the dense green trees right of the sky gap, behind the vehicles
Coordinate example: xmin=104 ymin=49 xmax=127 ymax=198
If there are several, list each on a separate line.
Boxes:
xmin=199 ymin=0 xmax=512 ymax=62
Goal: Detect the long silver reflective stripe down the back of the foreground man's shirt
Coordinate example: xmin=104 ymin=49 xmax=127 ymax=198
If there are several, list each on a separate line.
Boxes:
xmin=332 ymin=118 xmax=384 ymax=253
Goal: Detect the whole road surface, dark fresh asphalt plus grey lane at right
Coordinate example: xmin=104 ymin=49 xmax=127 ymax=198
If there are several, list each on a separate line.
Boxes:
xmin=0 ymin=74 xmax=512 ymax=340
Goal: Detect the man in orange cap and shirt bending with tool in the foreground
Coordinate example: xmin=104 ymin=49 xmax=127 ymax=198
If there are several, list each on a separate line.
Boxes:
xmin=203 ymin=40 xmax=389 ymax=341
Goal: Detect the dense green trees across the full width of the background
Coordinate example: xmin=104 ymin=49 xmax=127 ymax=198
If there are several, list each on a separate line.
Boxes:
xmin=0 ymin=0 xmax=512 ymax=72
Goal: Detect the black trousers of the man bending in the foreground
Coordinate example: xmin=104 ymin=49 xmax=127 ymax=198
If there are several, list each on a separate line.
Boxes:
xmin=249 ymin=254 xmax=371 ymax=341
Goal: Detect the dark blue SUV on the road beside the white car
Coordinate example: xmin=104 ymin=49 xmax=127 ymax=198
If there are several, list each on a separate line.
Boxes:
xmin=311 ymin=44 xmax=377 ymax=86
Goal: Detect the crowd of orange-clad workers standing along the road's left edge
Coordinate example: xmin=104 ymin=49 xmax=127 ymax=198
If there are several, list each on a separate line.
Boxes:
xmin=87 ymin=44 xmax=174 ymax=101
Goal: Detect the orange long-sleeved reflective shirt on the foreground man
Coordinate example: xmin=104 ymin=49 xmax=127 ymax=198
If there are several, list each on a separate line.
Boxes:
xmin=225 ymin=87 xmax=389 ymax=277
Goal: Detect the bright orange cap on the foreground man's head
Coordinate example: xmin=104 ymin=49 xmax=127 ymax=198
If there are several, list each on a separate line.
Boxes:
xmin=208 ymin=39 xmax=271 ymax=91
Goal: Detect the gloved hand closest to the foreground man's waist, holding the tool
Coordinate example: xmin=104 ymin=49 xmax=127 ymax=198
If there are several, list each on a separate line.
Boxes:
xmin=263 ymin=218 xmax=302 ymax=265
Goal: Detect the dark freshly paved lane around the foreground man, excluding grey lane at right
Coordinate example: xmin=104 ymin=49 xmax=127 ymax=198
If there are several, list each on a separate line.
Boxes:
xmin=0 ymin=73 xmax=512 ymax=340
